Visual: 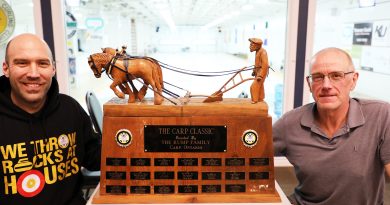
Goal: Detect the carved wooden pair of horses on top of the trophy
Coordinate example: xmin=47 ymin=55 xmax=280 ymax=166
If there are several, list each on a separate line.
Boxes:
xmin=88 ymin=53 xmax=164 ymax=105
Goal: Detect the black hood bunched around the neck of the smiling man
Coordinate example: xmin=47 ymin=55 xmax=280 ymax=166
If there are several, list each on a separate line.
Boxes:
xmin=0 ymin=75 xmax=59 ymax=121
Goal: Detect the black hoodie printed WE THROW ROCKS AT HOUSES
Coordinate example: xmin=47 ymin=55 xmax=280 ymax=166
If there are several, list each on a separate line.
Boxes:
xmin=0 ymin=76 xmax=101 ymax=205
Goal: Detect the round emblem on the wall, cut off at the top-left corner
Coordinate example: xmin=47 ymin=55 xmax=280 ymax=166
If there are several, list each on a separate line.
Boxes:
xmin=0 ymin=0 xmax=15 ymax=45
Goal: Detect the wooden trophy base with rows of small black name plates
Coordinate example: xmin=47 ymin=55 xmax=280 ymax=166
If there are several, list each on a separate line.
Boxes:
xmin=92 ymin=98 xmax=280 ymax=203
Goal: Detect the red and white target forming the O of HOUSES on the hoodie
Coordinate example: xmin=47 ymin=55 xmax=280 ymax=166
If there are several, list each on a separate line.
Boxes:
xmin=17 ymin=170 xmax=45 ymax=197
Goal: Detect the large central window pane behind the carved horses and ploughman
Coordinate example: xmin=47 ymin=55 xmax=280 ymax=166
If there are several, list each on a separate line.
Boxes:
xmin=66 ymin=0 xmax=287 ymax=117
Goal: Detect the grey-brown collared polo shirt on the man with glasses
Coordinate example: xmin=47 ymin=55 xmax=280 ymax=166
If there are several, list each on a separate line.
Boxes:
xmin=273 ymin=99 xmax=390 ymax=205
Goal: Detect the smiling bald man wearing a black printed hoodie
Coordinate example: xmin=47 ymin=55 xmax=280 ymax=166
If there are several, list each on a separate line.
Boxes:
xmin=0 ymin=34 xmax=101 ymax=205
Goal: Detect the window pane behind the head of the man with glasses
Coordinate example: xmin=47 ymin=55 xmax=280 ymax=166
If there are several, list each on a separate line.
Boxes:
xmin=314 ymin=0 xmax=390 ymax=102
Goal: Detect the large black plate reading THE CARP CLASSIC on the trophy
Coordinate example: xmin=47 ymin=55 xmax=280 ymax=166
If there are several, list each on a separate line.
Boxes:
xmin=144 ymin=125 xmax=227 ymax=152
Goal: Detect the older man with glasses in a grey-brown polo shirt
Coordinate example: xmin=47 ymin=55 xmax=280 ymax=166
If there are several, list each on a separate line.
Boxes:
xmin=273 ymin=48 xmax=390 ymax=205
